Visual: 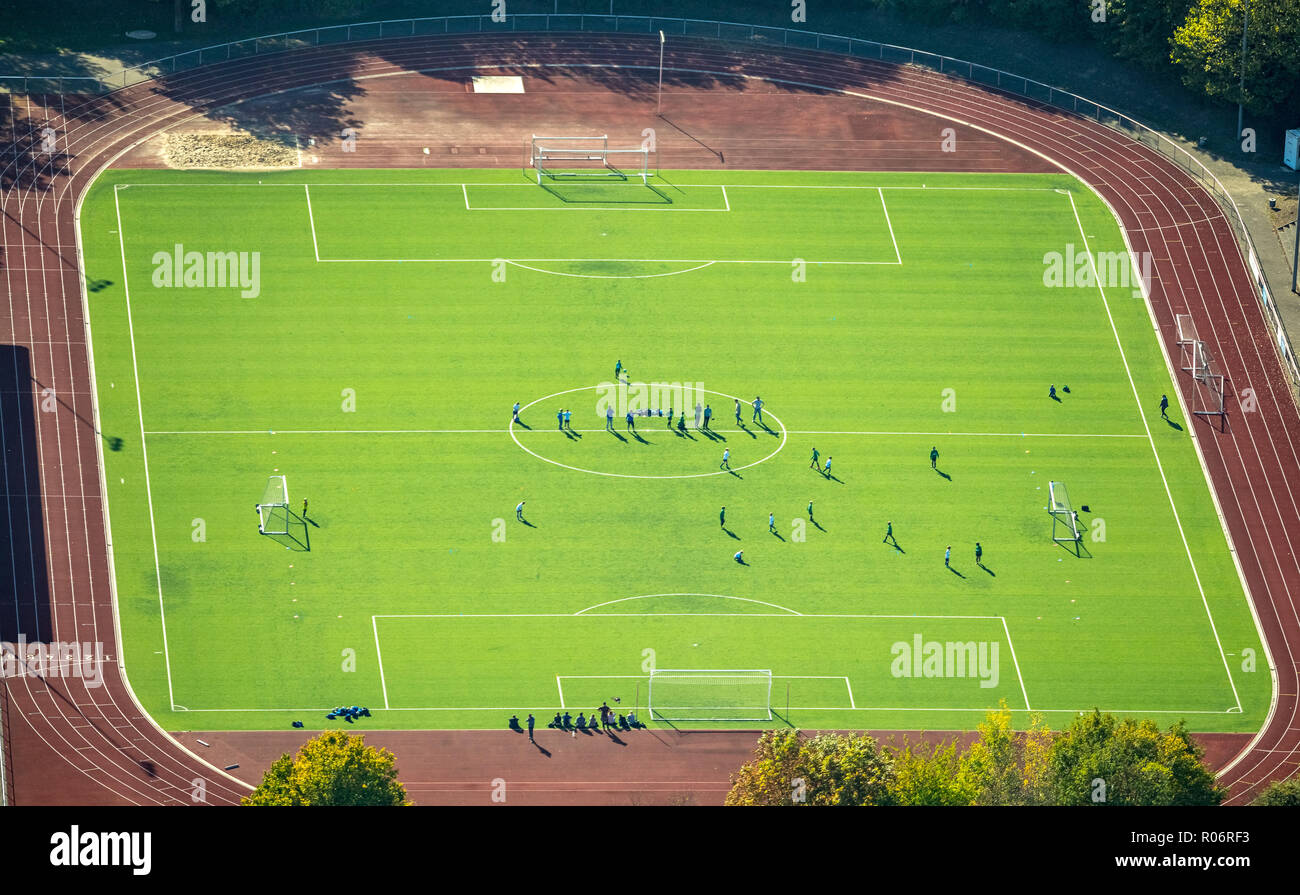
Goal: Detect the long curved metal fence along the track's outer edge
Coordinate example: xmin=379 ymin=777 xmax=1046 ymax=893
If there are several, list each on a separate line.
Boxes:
xmin=0 ymin=14 xmax=1300 ymax=385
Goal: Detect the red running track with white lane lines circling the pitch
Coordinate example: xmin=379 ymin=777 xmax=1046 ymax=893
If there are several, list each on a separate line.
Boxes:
xmin=0 ymin=34 xmax=1300 ymax=804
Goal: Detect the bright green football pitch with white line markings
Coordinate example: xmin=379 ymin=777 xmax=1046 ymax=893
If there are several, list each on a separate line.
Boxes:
xmin=81 ymin=170 xmax=1270 ymax=731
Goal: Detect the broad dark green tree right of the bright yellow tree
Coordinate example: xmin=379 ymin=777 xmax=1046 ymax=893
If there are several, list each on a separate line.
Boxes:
xmin=1048 ymin=710 xmax=1227 ymax=805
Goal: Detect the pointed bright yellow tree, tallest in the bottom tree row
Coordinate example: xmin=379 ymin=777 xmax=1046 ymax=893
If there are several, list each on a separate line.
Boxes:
xmin=961 ymin=701 xmax=1053 ymax=805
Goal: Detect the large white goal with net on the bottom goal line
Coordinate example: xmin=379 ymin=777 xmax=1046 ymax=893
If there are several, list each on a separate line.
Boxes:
xmin=647 ymin=669 xmax=772 ymax=721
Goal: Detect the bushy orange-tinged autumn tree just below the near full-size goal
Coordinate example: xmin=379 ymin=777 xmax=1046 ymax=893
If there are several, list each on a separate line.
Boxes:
xmin=725 ymin=730 xmax=892 ymax=805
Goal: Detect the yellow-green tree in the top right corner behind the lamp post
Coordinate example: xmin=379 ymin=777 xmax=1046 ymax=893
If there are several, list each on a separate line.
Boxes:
xmin=1171 ymin=0 xmax=1300 ymax=114
